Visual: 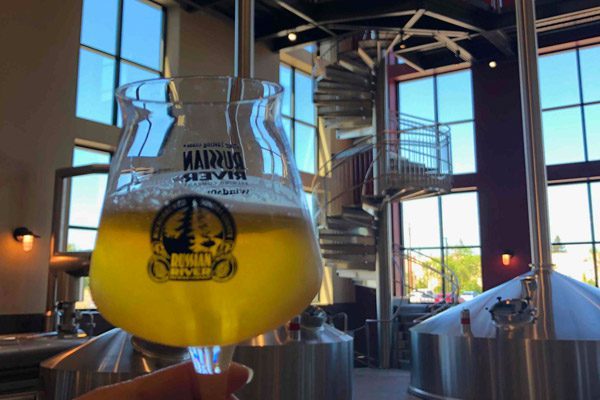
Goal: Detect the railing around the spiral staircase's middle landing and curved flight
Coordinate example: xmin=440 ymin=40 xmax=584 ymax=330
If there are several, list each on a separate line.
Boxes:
xmin=312 ymin=113 xmax=452 ymax=222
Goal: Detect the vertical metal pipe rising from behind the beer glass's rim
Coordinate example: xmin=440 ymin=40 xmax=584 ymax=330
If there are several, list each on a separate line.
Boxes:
xmin=234 ymin=0 xmax=254 ymax=78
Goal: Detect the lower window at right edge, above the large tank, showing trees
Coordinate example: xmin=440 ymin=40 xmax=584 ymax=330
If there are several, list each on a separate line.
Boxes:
xmin=548 ymin=182 xmax=600 ymax=286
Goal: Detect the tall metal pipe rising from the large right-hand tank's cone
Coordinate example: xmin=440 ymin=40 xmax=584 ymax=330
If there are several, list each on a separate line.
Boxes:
xmin=515 ymin=0 xmax=552 ymax=270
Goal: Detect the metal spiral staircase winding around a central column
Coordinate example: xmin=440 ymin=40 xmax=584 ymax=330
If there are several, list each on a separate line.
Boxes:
xmin=313 ymin=31 xmax=459 ymax=366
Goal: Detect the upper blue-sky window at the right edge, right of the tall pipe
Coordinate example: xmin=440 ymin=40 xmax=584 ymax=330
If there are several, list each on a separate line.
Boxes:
xmin=539 ymin=46 xmax=600 ymax=165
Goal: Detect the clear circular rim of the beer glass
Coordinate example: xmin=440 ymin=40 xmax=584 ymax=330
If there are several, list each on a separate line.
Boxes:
xmin=115 ymin=75 xmax=283 ymax=106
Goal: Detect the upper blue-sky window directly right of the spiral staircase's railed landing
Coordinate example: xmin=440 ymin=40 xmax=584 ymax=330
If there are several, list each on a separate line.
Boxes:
xmin=398 ymin=70 xmax=477 ymax=174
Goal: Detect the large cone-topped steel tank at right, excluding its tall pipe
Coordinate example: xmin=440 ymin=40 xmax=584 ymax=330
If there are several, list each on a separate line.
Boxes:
xmin=409 ymin=270 xmax=600 ymax=400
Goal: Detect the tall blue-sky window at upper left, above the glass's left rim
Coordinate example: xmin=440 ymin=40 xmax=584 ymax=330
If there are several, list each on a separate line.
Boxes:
xmin=75 ymin=0 xmax=165 ymax=125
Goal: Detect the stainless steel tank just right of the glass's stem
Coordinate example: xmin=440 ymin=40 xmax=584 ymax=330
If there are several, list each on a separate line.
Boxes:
xmin=234 ymin=325 xmax=354 ymax=400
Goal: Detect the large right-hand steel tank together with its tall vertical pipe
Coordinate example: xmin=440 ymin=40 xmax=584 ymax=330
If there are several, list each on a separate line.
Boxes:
xmin=409 ymin=0 xmax=600 ymax=400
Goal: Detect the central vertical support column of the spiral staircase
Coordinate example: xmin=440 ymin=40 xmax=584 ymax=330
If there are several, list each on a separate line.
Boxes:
xmin=373 ymin=57 xmax=393 ymax=368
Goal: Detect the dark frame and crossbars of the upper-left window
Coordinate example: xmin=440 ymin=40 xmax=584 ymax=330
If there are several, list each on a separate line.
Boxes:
xmin=75 ymin=0 xmax=167 ymax=126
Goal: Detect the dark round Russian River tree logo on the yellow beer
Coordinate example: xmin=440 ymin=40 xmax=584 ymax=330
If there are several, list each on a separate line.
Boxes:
xmin=148 ymin=196 xmax=237 ymax=282
